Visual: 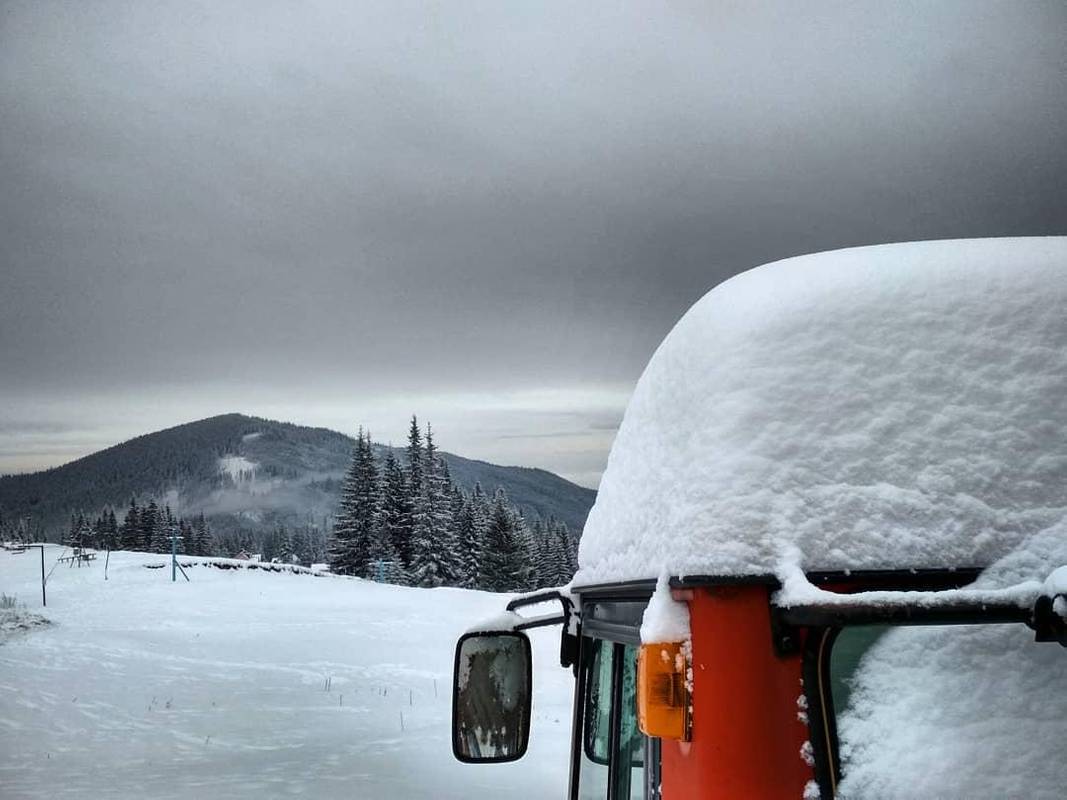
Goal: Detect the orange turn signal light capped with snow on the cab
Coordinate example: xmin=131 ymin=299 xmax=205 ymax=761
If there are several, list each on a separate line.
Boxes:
xmin=637 ymin=642 xmax=690 ymax=741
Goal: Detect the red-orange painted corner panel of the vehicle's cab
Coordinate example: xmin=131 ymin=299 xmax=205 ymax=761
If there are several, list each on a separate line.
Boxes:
xmin=663 ymin=587 xmax=814 ymax=800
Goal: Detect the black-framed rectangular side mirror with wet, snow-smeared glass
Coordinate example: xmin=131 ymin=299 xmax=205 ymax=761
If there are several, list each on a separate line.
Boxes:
xmin=452 ymin=630 xmax=532 ymax=764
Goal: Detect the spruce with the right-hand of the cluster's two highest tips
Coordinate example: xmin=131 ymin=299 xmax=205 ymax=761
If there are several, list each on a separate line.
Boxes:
xmin=409 ymin=426 xmax=461 ymax=587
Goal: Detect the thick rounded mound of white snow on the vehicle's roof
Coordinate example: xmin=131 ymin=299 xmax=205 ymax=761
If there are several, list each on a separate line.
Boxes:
xmin=575 ymin=237 xmax=1067 ymax=585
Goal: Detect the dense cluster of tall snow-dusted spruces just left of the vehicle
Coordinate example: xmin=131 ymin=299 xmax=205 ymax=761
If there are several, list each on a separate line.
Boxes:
xmin=328 ymin=416 xmax=577 ymax=592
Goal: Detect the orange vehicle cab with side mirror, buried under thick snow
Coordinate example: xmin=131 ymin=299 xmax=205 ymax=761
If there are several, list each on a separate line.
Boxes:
xmin=452 ymin=238 xmax=1067 ymax=800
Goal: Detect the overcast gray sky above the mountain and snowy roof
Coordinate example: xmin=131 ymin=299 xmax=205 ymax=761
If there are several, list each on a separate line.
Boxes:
xmin=0 ymin=0 xmax=1067 ymax=485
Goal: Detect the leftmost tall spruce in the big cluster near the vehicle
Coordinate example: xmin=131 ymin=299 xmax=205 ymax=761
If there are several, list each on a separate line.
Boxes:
xmin=330 ymin=428 xmax=381 ymax=577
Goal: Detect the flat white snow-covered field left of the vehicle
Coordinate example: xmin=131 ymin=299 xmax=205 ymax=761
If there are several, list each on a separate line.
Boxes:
xmin=0 ymin=548 xmax=572 ymax=800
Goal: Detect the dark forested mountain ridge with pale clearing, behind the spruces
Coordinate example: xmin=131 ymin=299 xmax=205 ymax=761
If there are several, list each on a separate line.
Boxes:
xmin=0 ymin=414 xmax=596 ymax=535
